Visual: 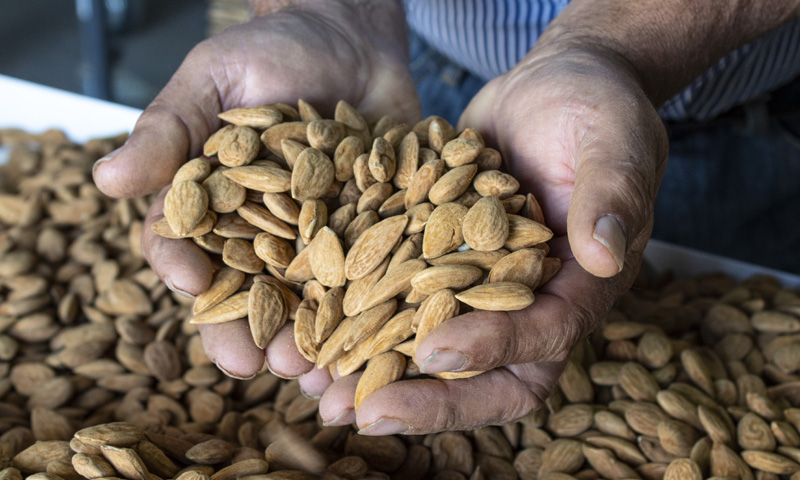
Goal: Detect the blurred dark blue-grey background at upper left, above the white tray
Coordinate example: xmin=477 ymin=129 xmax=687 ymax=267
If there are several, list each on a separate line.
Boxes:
xmin=0 ymin=0 xmax=249 ymax=108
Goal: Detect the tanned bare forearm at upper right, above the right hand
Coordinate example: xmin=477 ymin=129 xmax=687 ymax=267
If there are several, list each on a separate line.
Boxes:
xmin=530 ymin=0 xmax=800 ymax=105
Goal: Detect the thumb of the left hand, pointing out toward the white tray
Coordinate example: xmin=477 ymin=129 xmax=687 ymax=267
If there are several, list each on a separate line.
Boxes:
xmin=93 ymin=44 xmax=221 ymax=197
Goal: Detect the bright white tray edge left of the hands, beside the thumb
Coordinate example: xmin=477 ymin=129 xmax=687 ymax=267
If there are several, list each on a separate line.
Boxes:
xmin=0 ymin=75 xmax=142 ymax=142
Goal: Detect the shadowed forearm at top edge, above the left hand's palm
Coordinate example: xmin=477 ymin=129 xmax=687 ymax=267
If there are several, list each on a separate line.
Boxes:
xmin=250 ymin=0 xmax=408 ymax=61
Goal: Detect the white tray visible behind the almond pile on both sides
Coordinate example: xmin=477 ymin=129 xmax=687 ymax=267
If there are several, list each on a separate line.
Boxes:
xmin=0 ymin=75 xmax=800 ymax=288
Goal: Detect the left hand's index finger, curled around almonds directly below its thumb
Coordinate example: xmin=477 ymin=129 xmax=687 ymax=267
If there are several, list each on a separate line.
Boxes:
xmin=142 ymin=188 xmax=214 ymax=297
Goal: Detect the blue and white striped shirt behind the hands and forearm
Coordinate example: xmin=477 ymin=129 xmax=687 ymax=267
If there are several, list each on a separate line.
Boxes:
xmin=405 ymin=0 xmax=800 ymax=121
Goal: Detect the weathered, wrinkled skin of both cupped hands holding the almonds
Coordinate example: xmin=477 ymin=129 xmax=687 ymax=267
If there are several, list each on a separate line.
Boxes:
xmin=95 ymin=5 xmax=667 ymax=435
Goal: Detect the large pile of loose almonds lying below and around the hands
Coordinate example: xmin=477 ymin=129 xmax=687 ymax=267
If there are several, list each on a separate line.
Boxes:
xmin=0 ymin=123 xmax=800 ymax=480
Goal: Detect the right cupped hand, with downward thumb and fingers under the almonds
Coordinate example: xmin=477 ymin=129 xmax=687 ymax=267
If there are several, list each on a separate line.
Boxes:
xmin=320 ymin=48 xmax=667 ymax=435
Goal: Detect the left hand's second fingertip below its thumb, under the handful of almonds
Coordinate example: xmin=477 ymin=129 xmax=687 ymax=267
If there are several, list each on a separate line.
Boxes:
xmin=197 ymin=319 xmax=264 ymax=379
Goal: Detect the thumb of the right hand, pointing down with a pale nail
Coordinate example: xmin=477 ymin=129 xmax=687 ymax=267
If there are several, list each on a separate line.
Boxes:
xmin=567 ymin=119 xmax=667 ymax=277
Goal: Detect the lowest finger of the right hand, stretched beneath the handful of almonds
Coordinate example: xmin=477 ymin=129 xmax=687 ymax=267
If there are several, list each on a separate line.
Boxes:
xmin=357 ymin=364 xmax=563 ymax=435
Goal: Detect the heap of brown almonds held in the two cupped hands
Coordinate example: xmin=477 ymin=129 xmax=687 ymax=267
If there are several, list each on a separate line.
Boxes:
xmin=152 ymin=100 xmax=560 ymax=404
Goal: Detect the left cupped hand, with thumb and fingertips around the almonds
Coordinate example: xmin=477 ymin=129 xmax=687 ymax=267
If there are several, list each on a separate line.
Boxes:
xmin=94 ymin=0 xmax=420 ymax=382
